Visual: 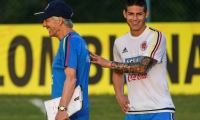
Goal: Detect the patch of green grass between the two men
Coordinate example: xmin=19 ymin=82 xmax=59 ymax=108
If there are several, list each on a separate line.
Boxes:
xmin=89 ymin=95 xmax=124 ymax=120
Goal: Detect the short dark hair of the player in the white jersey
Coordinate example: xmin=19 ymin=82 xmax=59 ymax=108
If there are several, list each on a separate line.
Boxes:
xmin=125 ymin=0 xmax=147 ymax=13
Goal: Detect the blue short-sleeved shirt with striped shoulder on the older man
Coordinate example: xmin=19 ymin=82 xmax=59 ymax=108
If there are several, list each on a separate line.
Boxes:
xmin=52 ymin=32 xmax=90 ymax=118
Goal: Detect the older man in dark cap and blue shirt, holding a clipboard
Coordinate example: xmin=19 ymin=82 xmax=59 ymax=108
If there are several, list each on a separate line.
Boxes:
xmin=35 ymin=0 xmax=90 ymax=120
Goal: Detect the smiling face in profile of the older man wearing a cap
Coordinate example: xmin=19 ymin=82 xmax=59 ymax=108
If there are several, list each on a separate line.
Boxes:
xmin=42 ymin=17 xmax=59 ymax=37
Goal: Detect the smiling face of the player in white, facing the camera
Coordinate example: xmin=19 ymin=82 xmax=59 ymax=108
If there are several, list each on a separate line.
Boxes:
xmin=123 ymin=5 xmax=148 ymax=36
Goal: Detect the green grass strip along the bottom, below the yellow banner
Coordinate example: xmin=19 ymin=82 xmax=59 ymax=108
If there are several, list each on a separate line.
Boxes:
xmin=0 ymin=95 xmax=200 ymax=120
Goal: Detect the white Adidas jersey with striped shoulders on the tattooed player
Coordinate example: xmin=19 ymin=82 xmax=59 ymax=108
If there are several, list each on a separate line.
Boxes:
xmin=113 ymin=27 xmax=175 ymax=114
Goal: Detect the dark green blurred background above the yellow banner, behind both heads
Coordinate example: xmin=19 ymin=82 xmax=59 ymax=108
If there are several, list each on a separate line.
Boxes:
xmin=0 ymin=0 xmax=200 ymax=24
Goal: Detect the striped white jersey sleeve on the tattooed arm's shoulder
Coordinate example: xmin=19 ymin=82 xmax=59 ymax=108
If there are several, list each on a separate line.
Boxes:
xmin=145 ymin=31 xmax=166 ymax=63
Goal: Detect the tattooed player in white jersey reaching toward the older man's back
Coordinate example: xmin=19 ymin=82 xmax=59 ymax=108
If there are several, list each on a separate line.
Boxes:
xmin=91 ymin=0 xmax=175 ymax=120
